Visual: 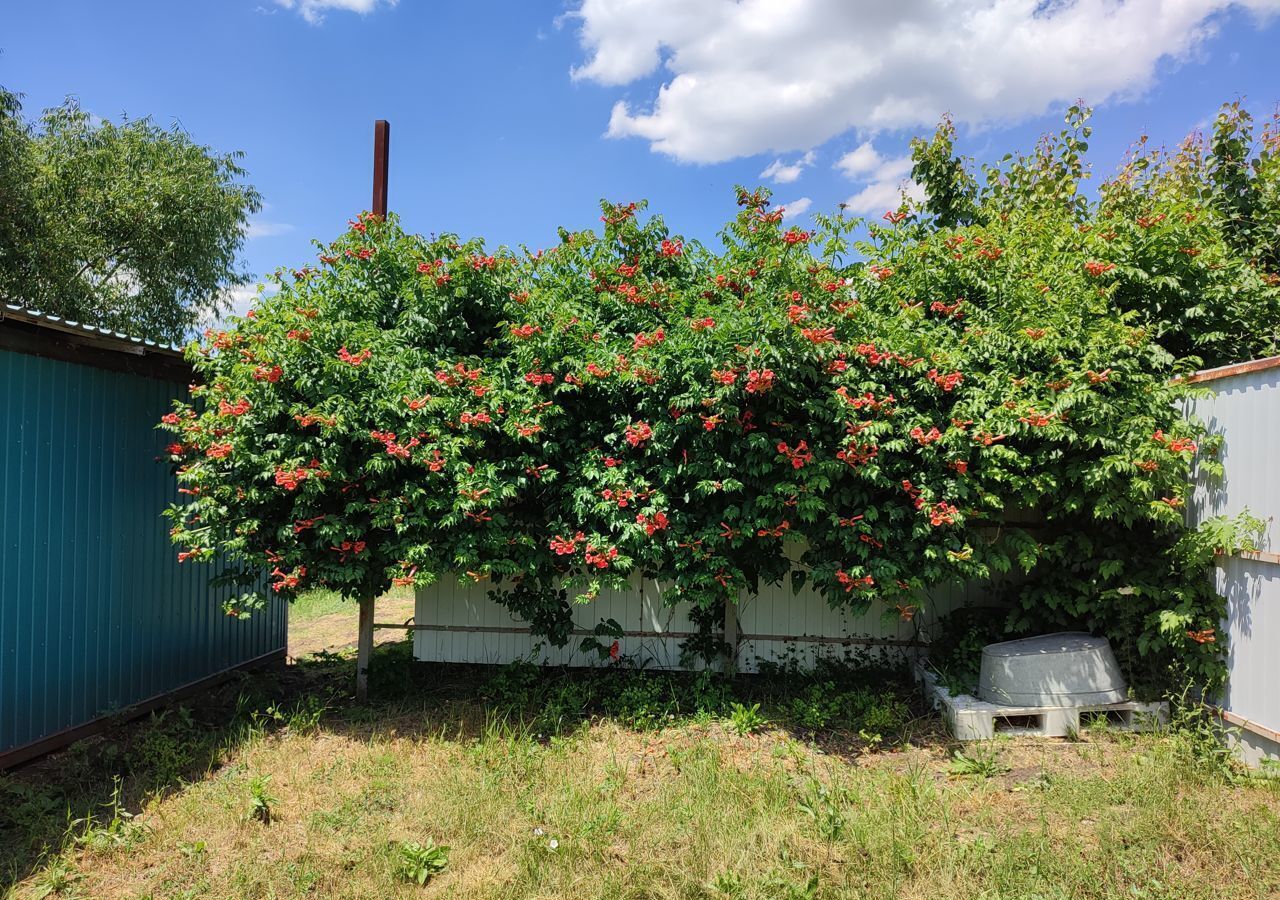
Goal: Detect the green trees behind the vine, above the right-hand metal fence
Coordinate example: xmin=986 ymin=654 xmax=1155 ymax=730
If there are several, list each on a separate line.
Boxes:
xmin=911 ymin=102 xmax=1280 ymax=367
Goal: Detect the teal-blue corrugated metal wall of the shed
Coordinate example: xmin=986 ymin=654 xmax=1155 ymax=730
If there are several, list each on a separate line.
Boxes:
xmin=0 ymin=351 xmax=285 ymax=753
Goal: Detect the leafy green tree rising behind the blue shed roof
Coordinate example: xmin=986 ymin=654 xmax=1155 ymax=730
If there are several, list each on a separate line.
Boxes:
xmin=0 ymin=88 xmax=261 ymax=342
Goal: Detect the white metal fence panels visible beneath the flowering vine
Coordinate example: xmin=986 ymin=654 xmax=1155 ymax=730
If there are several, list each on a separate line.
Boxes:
xmin=413 ymin=576 xmax=979 ymax=672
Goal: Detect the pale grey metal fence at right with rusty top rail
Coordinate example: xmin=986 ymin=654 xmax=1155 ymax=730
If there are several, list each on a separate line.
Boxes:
xmin=1188 ymin=367 xmax=1280 ymax=759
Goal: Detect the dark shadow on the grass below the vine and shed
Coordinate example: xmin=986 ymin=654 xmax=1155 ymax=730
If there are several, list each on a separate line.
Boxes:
xmin=0 ymin=640 xmax=947 ymax=890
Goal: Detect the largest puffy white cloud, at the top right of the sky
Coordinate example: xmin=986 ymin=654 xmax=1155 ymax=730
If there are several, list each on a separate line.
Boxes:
xmin=570 ymin=0 xmax=1280 ymax=163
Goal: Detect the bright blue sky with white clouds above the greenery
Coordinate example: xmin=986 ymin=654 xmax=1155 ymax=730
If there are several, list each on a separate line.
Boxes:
xmin=0 ymin=0 xmax=1280 ymax=317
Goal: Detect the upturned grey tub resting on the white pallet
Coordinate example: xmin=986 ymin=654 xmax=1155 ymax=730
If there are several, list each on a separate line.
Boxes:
xmin=978 ymin=631 xmax=1128 ymax=707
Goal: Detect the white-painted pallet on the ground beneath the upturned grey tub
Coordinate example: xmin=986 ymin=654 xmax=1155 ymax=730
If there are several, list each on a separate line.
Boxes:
xmin=914 ymin=664 xmax=1169 ymax=741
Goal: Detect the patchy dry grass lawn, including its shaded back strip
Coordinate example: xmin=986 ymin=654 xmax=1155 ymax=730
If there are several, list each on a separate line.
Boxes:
xmin=0 ymin=643 xmax=1280 ymax=899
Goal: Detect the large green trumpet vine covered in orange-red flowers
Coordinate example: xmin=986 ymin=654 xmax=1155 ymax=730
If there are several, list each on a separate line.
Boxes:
xmin=164 ymin=107 xmax=1280 ymax=684
